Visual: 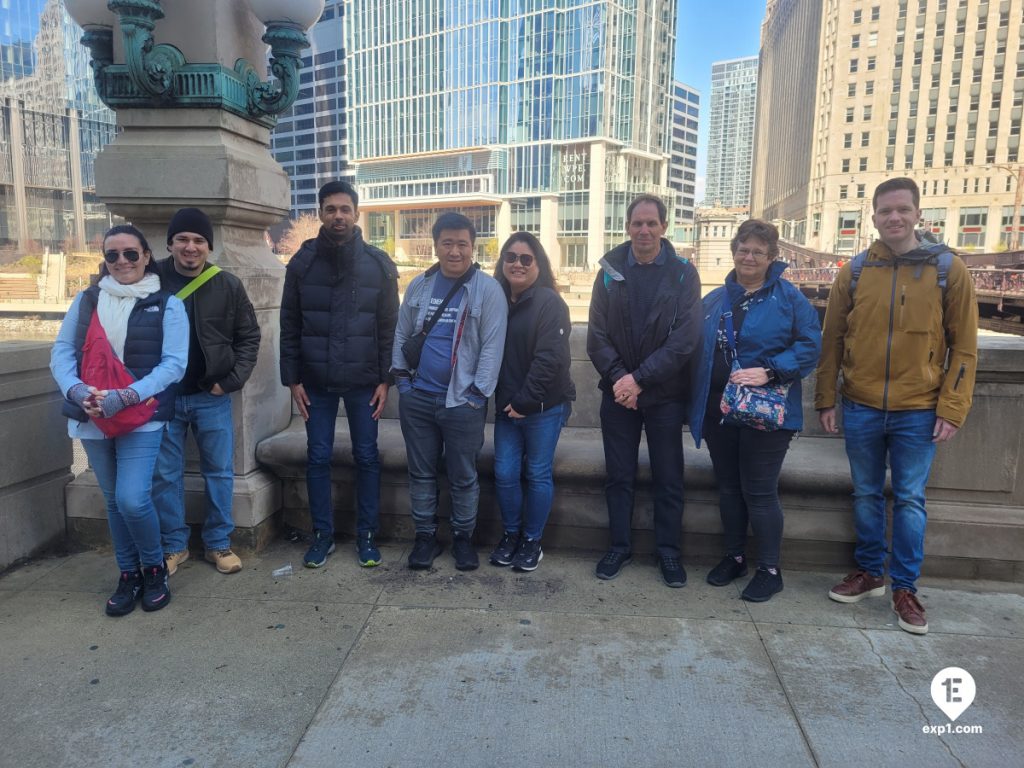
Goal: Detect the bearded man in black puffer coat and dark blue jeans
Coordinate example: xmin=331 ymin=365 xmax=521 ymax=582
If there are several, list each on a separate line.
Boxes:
xmin=281 ymin=181 xmax=398 ymax=568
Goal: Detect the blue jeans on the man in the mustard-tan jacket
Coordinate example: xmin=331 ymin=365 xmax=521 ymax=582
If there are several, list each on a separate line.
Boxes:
xmin=843 ymin=397 xmax=935 ymax=592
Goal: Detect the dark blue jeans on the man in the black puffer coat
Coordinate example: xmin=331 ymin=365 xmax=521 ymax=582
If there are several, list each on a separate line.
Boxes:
xmin=305 ymin=387 xmax=381 ymax=535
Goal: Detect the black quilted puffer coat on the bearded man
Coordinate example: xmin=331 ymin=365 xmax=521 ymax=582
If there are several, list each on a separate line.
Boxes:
xmin=281 ymin=222 xmax=398 ymax=392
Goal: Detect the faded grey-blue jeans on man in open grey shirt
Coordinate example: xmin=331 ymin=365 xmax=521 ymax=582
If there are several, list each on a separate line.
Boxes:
xmin=398 ymin=387 xmax=487 ymax=535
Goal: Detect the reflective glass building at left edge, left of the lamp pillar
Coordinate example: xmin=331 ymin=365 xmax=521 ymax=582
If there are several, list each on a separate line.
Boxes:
xmin=0 ymin=0 xmax=115 ymax=253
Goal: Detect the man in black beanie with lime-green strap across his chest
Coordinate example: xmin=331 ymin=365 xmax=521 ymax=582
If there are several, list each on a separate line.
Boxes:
xmin=153 ymin=208 xmax=260 ymax=574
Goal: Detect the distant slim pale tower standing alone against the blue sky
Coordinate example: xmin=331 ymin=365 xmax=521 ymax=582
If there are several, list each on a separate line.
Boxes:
xmin=705 ymin=56 xmax=758 ymax=208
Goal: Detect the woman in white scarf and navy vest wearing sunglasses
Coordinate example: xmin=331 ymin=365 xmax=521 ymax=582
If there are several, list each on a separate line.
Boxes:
xmin=50 ymin=224 xmax=188 ymax=616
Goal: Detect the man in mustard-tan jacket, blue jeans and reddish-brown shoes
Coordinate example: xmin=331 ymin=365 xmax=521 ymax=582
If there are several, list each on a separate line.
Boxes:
xmin=814 ymin=178 xmax=978 ymax=635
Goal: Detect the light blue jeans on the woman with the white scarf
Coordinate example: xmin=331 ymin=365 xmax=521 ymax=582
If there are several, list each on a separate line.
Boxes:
xmin=82 ymin=429 xmax=164 ymax=570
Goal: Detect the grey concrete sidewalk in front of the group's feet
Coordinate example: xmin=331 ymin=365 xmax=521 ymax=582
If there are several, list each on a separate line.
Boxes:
xmin=0 ymin=541 xmax=1024 ymax=768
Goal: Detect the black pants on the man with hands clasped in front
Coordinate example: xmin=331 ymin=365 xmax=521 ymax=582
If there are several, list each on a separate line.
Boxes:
xmin=601 ymin=392 xmax=686 ymax=557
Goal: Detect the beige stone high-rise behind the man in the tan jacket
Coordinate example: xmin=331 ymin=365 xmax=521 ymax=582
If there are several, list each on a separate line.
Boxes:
xmin=753 ymin=0 xmax=1024 ymax=259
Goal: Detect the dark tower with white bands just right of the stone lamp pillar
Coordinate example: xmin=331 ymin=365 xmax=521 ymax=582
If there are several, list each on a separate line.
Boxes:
xmin=270 ymin=0 xmax=352 ymax=218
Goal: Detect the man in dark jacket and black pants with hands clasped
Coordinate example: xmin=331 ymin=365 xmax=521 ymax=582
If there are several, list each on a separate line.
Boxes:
xmin=587 ymin=195 xmax=703 ymax=587
